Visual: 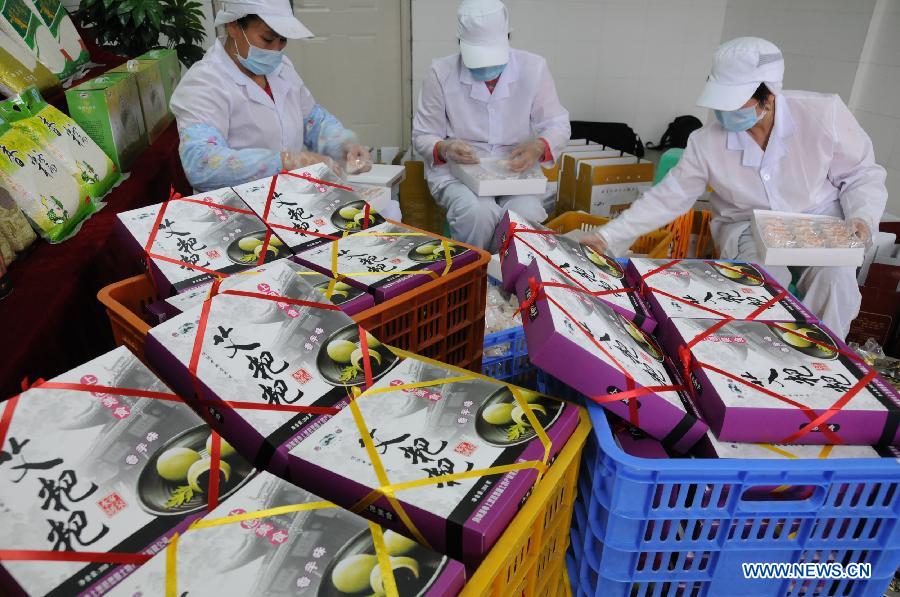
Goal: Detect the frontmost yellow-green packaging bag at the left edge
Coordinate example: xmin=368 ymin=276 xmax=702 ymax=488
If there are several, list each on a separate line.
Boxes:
xmin=0 ymin=110 xmax=100 ymax=243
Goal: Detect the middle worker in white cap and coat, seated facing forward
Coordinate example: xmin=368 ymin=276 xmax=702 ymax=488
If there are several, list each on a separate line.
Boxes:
xmin=413 ymin=0 xmax=570 ymax=248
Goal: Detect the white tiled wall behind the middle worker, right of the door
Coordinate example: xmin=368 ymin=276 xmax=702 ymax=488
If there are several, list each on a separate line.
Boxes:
xmin=412 ymin=0 xmax=728 ymax=146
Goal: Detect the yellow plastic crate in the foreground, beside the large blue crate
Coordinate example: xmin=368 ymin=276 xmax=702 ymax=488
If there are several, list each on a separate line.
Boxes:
xmin=460 ymin=409 xmax=591 ymax=597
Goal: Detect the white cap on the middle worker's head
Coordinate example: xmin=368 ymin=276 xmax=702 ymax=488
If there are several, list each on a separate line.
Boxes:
xmin=456 ymin=0 xmax=509 ymax=68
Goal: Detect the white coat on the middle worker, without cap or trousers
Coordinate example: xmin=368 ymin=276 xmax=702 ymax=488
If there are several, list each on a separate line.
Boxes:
xmin=413 ymin=50 xmax=570 ymax=192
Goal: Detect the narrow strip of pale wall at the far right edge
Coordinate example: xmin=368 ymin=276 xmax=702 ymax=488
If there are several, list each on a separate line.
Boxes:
xmin=850 ymin=0 xmax=900 ymax=216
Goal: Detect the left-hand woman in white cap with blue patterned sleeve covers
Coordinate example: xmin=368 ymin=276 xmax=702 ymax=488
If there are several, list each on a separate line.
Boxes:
xmin=171 ymin=0 xmax=371 ymax=191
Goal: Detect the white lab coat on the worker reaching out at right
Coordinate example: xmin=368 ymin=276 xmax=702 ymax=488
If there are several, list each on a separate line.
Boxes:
xmin=600 ymin=91 xmax=887 ymax=259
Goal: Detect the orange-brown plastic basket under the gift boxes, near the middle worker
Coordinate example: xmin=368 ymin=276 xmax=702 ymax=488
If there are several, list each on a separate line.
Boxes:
xmin=97 ymin=244 xmax=490 ymax=371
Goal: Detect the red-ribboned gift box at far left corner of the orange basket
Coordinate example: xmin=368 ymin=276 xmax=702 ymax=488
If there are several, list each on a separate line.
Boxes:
xmin=118 ymin=189 xmax=292 ymax=297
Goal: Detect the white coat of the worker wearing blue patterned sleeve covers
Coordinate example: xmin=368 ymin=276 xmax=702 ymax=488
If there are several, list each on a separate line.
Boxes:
xmin=171 ymin=40 xmax=316 ymax=152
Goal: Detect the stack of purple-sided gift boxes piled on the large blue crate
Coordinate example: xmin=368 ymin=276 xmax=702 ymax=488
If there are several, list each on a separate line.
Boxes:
xmin=497 ymin=213 xmax=900 ymax=458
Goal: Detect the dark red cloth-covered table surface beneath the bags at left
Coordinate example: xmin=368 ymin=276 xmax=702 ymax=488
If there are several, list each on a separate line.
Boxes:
xmin=0 ymin=124 xmax=190 ymax=400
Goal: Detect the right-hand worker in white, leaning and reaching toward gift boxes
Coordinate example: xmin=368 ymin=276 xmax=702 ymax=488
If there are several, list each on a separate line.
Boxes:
xmin=584 ymin=37 xmax=887 ymax=338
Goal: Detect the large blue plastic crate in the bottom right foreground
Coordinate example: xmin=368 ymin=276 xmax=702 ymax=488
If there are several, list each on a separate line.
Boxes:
xmin=571 ymin=396 xmax=900 ymax=597
